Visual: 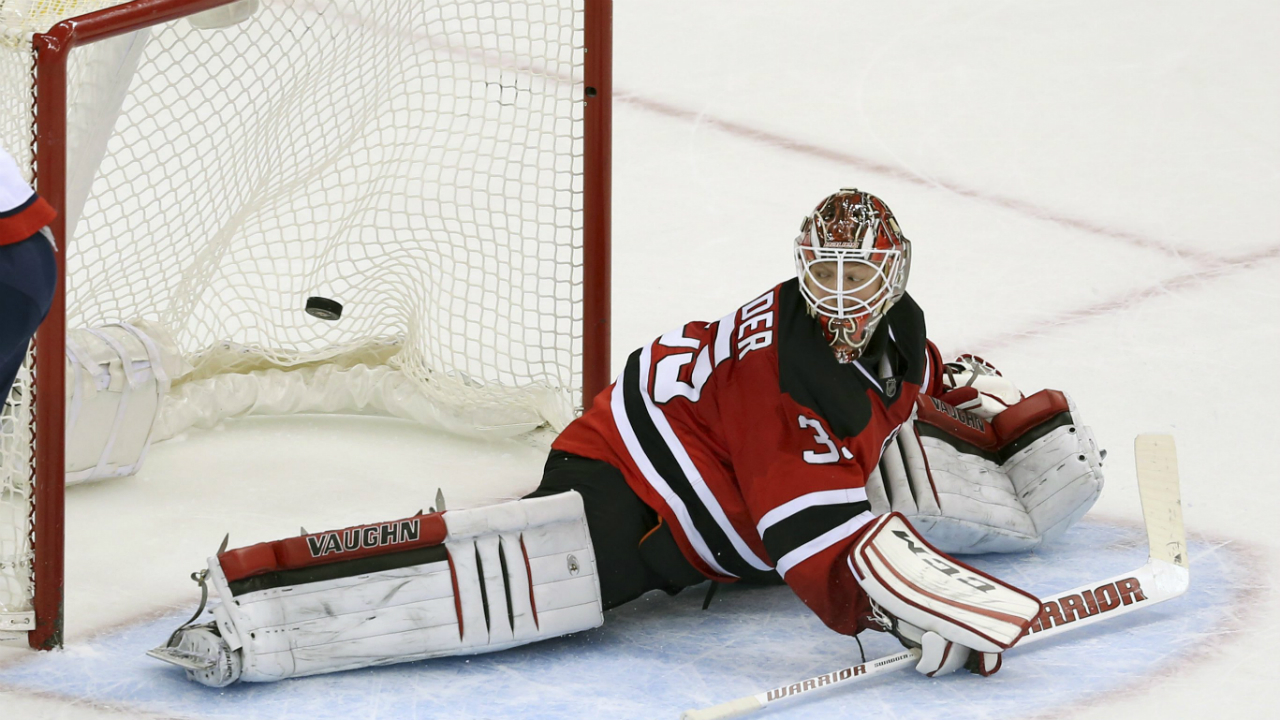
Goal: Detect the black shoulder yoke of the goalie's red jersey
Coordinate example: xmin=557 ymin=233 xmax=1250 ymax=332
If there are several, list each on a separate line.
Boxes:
xmin=778 ymin=279 xmax=925 ymax=438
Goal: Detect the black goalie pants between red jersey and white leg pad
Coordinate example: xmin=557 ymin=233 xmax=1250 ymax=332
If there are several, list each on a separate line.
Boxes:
xmin=527 ymin=450 xmax=707 ymax=610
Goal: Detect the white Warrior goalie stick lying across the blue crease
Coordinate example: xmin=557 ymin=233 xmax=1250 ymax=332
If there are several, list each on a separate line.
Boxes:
xmin=680 ymin=434 xmax=1190 ymax=720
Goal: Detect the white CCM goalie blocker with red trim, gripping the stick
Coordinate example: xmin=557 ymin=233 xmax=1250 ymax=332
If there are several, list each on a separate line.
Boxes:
xmin=849 ymin=512 xmax=1041 ymax=678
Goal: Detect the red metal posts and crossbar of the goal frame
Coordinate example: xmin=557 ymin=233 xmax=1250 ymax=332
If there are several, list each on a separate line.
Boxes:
xmin=0 ymin=0 xmax=612 ymax=648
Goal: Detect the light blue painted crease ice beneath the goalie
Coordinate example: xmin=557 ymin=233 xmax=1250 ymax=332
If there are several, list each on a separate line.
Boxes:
xmin=0 ymin=523 xmax=1248 ymax=720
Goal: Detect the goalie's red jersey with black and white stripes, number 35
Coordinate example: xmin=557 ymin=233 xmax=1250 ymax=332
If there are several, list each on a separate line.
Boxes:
xmin=553 ymin=279 xmax=942 ymax=634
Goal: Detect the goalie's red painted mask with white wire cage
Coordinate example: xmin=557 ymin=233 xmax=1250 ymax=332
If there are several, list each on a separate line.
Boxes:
xmin=795 ymin=188 xmax=911 ymax=363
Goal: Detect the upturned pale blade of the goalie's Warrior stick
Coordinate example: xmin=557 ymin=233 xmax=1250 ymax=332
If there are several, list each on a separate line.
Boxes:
xmin=1133 ymin=434 xmax=1190 ymax=569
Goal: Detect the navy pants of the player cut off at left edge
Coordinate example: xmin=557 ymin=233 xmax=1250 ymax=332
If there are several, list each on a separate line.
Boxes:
xmin=0 ymin=233 xmax=58 ymax=397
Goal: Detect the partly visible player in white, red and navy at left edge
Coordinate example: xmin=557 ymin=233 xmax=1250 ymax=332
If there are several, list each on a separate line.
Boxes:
xmin=0 ymin=149 xmax=58 ymax=404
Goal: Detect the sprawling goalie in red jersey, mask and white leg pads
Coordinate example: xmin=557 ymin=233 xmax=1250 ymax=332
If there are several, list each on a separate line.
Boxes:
xmin=154 ymin=190 xmax=1102 ymax=687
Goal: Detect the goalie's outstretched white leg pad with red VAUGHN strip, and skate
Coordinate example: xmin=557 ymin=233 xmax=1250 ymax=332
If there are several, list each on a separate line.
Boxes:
xmin=151 ymin=492 xmax=603 ymax=687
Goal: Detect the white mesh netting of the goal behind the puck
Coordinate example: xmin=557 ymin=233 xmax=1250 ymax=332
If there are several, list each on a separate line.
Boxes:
xmin=0 ymin=0 xmax=584 ymax=612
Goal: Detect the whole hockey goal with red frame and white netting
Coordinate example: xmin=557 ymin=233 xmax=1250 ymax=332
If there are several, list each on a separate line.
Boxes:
xmin=0 ymin=0 xmax=612 ymax=648
